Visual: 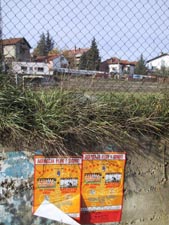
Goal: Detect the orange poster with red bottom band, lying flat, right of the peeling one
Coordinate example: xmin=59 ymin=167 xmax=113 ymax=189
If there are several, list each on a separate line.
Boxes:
xmin=80 ymin=152 xmax=126 ymax=224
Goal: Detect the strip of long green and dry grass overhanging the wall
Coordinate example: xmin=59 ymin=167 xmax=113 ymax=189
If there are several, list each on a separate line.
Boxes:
xmin=0 ymin=79 xmax=169 ymax=155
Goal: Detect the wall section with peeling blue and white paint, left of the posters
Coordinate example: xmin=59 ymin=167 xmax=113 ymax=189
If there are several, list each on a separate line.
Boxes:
xmin=0 ymin=151 xmax=55 ymax=225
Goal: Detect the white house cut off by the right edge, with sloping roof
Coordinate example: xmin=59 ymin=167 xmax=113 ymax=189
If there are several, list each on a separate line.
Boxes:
xmin=146 ymin=53 xmax=169 ymax=71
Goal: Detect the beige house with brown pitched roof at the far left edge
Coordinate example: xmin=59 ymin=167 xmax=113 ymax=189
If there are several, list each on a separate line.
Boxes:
xmin=0 ymin=38 xmax=31 ymax=64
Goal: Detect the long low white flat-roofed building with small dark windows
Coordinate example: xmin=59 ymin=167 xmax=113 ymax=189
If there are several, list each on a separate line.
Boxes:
xmin=12 ymin=62 xmax=53 ymax=75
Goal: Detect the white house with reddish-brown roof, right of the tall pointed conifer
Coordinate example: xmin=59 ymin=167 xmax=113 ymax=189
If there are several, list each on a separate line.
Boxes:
xmin=107 ymin=57 xmax=137 ymax=76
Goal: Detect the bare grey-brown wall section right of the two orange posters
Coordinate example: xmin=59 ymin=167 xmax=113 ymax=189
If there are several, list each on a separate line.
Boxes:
xmin=120 ymin=137 xmax=169 ymax=225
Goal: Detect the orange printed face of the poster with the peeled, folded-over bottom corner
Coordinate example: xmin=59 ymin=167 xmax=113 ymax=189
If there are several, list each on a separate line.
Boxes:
xmin=33 ymin=156 xmax=82 ymax=220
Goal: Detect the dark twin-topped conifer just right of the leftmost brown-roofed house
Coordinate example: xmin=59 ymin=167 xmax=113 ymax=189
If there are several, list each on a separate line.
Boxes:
xmin=33 ymin=32 xmax=54 ymax=56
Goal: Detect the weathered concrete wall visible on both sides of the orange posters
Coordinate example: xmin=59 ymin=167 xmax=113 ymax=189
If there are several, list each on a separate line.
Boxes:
xmin=0 ymin=140 xmax=169 ymax=225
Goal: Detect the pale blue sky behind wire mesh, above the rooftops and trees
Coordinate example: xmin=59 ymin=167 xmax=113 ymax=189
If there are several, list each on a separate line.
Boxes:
xmin=1 ymin=0 xmax=169 ymax=61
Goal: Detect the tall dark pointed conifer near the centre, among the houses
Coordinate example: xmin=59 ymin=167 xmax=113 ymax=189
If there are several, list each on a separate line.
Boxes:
xmin=79 ymin=38 xmax=101 ymax=70
